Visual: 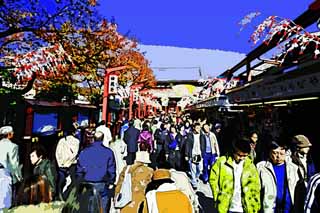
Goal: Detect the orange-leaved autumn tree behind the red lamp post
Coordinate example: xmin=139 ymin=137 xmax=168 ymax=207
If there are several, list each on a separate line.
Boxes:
xmin=39 ymin=20 xmax=155 ymax=103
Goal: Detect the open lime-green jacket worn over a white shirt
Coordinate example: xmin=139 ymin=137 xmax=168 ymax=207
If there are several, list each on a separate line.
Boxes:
xmin=209 ymin=156 xmax=261 ymax=213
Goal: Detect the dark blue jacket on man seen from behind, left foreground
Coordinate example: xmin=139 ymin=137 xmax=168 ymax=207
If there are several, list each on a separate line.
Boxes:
xmin=77 ymin=141 xmax=116 ymax=184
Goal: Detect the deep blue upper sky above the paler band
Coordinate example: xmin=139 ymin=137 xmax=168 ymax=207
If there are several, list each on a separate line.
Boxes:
xmin=100 ymin=0 xmax=313 ymax=53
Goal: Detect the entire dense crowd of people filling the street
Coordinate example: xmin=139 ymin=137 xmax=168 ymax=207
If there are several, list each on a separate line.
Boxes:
xmin=0 ymin=113 xmax=320 ymax=213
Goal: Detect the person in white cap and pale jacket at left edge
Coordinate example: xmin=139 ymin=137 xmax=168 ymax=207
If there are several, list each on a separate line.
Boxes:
xmin=0 ymin=126 xmax=22 ymax=211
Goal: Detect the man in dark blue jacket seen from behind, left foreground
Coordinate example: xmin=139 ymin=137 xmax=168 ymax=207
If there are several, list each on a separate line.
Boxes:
xmin=76 ymin=131 xmax=116 ymax=212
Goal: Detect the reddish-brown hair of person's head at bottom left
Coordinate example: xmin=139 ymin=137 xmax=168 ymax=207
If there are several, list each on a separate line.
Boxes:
xmin=16 ymin=176 xmax=52 ymax=205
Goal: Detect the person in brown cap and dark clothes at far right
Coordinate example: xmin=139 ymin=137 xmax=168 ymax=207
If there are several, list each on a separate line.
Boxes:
xmin=291 ymin=135 xmax=316 ymax=212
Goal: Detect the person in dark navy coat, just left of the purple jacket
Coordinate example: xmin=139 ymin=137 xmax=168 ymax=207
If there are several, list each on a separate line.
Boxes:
xmin=123 ymin=120 xmax=140 ymax=165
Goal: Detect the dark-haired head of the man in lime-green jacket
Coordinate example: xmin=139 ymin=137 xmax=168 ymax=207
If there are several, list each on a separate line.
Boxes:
xmin=232 ymin=138 xmax=251 ymax=163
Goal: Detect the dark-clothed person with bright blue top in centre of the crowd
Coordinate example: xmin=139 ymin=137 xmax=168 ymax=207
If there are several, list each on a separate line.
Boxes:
xmin=165 ymin=126 xmax=183 ymax=170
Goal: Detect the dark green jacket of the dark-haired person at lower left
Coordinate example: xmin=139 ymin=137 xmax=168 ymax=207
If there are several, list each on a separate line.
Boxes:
xmin=33 ymin=159 xmax=57 ymax=196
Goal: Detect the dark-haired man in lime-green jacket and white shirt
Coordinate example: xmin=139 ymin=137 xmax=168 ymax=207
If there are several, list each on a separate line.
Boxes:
xmin=209 ymin=138 xmax=261 ymax=213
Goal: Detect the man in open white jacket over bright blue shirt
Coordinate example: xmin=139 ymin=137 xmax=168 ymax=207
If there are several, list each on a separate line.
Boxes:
xmin=257 ymin=141 xmax=299 ymax=212
